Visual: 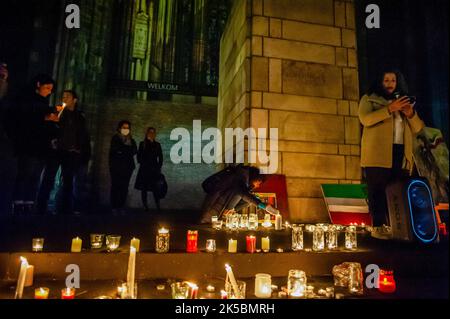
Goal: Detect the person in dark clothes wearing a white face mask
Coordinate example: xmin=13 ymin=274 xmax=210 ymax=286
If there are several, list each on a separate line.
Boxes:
xmin=109 ymin=120 xmax=137 ymax=215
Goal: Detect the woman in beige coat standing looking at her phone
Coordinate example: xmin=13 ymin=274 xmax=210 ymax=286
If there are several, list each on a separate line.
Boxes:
xmin=359 ymin=71 xmax=424 ymax=238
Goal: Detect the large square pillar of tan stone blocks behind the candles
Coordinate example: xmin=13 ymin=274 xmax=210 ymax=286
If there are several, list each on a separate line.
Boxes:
xmin=218 ymin=0 xmax=361 ymax=222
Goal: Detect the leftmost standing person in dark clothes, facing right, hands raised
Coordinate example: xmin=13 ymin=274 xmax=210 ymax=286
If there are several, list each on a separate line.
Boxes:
xmin=9 ymin=75 xmax=58 ymax=213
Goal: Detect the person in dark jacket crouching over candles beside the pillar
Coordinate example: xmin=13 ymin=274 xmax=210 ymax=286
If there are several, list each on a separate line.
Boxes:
xmin=200 ymin=165 xmax=276 ymax=224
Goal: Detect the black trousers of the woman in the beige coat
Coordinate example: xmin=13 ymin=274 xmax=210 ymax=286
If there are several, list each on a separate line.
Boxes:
xmin=364 ymin=144 xmax=405 ymax=227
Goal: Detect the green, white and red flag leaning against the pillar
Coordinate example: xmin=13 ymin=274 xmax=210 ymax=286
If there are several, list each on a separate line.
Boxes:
xmin=322 ymin=184 xmax=372 ymax=225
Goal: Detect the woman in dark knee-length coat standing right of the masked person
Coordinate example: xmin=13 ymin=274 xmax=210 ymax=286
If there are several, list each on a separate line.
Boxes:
xmin=135 ymin=127 xmax=163 ymax=211
